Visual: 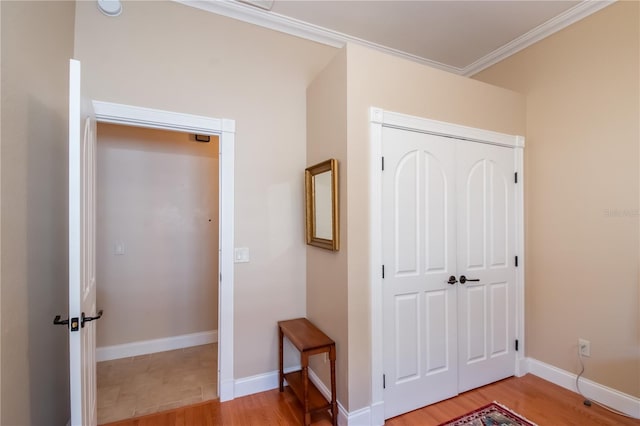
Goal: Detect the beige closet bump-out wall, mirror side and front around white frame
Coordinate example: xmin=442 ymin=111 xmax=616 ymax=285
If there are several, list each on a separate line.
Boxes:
xmin=307 ymin=41 xmax=525 ymax=412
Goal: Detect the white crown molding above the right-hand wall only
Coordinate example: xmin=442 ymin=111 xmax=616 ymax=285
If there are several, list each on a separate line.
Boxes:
xmin=460 ymin=0 xmax=616 ymax=77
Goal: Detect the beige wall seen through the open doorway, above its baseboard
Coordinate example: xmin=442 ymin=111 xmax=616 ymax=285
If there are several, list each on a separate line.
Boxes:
xmin=96 ymin=123 xmax=218 ymax=347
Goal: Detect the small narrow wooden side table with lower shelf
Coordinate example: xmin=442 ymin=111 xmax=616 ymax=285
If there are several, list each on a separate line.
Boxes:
xmin=278 ymin=318 xmax=338 ymax=426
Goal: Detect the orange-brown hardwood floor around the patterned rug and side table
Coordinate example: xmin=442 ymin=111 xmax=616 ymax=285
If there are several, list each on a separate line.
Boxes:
xmin=102 ymin=374 xmax=640 ymax=426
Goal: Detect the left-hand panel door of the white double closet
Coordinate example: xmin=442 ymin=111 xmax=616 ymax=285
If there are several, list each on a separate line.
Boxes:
xmin=382 ymin=127 xmax=458 ymax=418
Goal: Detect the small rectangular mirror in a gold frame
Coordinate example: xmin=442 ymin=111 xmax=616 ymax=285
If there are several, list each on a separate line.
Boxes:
xmin=304 ymin=158 xmax=340 ymax=251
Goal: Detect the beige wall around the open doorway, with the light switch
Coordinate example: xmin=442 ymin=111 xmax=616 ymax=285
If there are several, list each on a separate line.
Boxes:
xmin=75 ymin=2 xmax=335 ymax=378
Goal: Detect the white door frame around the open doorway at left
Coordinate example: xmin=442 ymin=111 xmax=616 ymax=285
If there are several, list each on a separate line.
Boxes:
xmin=93 ymin=100 xmax=235 ymax=401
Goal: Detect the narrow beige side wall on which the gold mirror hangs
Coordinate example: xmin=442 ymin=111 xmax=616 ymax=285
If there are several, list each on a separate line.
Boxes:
xmin=307 ymin=49 xmax=349 ymax=407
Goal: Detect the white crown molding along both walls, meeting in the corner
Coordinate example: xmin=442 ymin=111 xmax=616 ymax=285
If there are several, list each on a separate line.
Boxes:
xmin=173 ymin=0 xmax=616 ymax=77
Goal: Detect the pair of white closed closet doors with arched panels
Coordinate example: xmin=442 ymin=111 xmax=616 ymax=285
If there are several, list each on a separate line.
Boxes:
xmin=382 ymin=127 xmax=516 ymax=418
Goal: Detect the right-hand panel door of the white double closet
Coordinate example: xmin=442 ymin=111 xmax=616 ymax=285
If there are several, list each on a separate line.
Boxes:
xmin=456 ymin=141 xmax=516 ymax=392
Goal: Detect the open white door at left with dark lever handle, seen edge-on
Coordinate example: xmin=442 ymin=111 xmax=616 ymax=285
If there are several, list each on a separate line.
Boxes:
xmin=69 ymin=59 xmax=97 ymax=426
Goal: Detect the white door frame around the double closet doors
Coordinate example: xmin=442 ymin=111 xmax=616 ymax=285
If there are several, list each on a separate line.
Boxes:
xmin=369 ymin=107 xmax=527 ymax=425
